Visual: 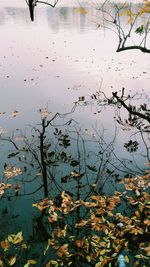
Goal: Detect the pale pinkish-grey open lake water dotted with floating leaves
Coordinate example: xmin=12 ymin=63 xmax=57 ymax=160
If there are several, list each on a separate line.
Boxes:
xmin=0 ymin=0 xmax=150 ymax=240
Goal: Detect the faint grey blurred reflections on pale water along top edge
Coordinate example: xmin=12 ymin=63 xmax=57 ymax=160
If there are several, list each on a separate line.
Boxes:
xmin=0 ymin=6 xmax=96 ymax=33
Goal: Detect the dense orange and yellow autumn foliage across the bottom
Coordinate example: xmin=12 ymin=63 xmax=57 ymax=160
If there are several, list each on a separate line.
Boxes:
xmin=0 ymin=172 xmax=150 ymax=267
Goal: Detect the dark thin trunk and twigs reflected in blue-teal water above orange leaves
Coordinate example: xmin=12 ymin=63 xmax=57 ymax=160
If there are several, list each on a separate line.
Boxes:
xmin=1 ymin=99 xmax=150 ymax=206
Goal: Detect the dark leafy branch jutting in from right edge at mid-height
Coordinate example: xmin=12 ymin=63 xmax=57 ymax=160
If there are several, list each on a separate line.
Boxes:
xmin=87 ymin=88 xmax=150 ymax=165
